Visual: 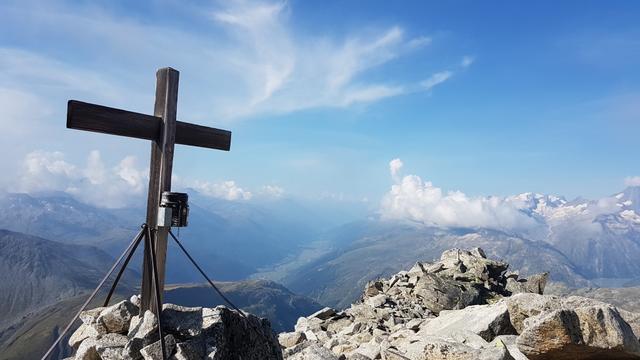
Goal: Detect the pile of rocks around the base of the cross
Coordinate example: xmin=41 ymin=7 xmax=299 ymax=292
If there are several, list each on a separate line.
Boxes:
xmin=69 ymin=296 xmax=282 ymax=360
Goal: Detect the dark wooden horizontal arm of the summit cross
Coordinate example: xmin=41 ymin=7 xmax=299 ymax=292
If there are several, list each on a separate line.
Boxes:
xmin=67 ymin=100 xmax=231 ymax=151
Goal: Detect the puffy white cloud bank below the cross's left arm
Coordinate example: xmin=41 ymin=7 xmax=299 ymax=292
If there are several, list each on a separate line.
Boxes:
xmin=12 ymin=151 xmax=146 ymax=208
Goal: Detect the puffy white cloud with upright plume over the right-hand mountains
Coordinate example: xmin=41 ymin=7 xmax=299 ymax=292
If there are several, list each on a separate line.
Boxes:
xmin=380 ymin=159 xmax=535 ymax=229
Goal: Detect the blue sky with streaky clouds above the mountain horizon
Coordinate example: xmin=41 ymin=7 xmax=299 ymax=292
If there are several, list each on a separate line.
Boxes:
xmin=0 ymin=0 xmax=640 ymax=208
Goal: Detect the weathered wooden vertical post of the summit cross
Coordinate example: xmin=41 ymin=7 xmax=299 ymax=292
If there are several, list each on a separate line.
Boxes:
xmin=140 ymin=68 xmax=180 ymax=313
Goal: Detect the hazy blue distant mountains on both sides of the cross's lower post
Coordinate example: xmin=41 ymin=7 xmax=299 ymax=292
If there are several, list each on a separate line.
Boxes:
xmin=0 ymin=191 xmax=352 ymax=283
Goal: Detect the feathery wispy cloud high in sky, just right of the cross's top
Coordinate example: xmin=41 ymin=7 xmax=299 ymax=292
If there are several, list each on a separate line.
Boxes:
xmin=213 ymin=2 xmax=430 ymax=116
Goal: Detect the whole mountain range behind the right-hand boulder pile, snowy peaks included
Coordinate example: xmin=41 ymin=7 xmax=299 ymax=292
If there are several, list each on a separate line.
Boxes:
xmin=264 ymin=187 xmax=640 ymax=307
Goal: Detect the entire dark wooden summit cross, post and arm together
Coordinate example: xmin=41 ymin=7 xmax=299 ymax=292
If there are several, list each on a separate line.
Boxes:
xmin=67 ymin=68 xmax=231 ymax=313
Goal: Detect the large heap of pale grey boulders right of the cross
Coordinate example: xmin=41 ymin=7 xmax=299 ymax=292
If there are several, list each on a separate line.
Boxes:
xmin=279 ymin=248 xmax=640 ymax=360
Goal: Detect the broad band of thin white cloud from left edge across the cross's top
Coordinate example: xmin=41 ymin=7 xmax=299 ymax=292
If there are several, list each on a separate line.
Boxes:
xmin=0 ymin=1 xmax=472 ymax=119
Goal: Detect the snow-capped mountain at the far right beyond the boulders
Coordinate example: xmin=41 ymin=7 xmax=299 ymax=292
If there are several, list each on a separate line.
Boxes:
xmin=510 ymin=187 xmax=640 ymax=278
